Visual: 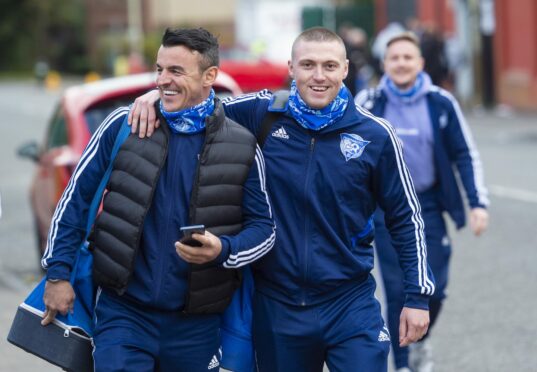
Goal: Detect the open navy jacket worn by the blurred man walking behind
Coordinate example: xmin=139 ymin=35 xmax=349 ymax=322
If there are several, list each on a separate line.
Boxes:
xmin=355 ymin=85 xmax=489 ymax=228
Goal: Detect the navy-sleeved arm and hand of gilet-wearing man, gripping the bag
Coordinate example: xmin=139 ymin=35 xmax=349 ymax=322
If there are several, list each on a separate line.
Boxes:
xmin=41 ymin=108 xmax=127 ymax=325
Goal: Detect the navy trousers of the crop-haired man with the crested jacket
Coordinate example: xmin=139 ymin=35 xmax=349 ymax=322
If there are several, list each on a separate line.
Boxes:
xmin=253 ymin=275 xmax=390 ymax=372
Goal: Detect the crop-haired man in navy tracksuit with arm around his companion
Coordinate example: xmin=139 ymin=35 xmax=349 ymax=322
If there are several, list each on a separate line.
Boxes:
xmin=133 ymin=28 xmax=434 ymax=372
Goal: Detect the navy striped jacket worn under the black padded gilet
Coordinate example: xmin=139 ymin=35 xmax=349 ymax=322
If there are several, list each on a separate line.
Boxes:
xmin=42 ymin=107 xmax=275 ymax=310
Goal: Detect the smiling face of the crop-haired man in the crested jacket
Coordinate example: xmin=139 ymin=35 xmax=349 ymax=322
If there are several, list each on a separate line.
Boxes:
xmin=289 ymin=39 xmax=349 ymax=109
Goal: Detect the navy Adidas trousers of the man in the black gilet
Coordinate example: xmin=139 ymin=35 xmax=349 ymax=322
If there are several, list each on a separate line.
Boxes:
xmin=93 ymin=291 xmax=221 ymax=372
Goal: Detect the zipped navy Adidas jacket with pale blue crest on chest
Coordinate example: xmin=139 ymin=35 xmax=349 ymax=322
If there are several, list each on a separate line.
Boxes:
xmin=223 ymin=91 xmax=434 ymax=309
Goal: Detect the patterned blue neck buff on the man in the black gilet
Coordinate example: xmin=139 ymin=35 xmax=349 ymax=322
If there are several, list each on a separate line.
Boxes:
xmin=160 ymin=89 xmax=214 ymax=134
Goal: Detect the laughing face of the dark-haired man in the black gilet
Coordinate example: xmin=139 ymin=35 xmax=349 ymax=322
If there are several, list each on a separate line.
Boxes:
xmin=156 ymin=45 xmax=218 ymax=112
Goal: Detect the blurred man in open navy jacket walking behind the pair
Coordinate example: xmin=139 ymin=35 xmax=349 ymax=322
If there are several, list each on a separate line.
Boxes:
xmin=356 ymin=33 xmax=488 ymax=372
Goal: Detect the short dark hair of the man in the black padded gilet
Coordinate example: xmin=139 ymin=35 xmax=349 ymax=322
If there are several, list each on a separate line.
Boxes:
xmin=162 ymin=27 xmax=220 ymax=71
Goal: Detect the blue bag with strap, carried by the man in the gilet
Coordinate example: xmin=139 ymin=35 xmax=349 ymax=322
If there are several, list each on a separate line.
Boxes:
xmin=7 ymin=118 xmax=130 ymax=372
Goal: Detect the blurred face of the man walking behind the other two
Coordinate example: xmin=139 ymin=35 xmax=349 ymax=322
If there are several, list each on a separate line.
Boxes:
xmin=384 ymin=39 xmax=424 ymax=90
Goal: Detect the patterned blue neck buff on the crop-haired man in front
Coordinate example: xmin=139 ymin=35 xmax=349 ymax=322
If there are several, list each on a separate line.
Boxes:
xmin=289 ymin=80 xmax=349 ymax=130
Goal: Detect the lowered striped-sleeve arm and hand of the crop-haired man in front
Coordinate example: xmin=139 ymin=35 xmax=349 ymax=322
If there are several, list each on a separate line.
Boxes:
xmin=375 ymin=120 xmax=434 ymax=346
